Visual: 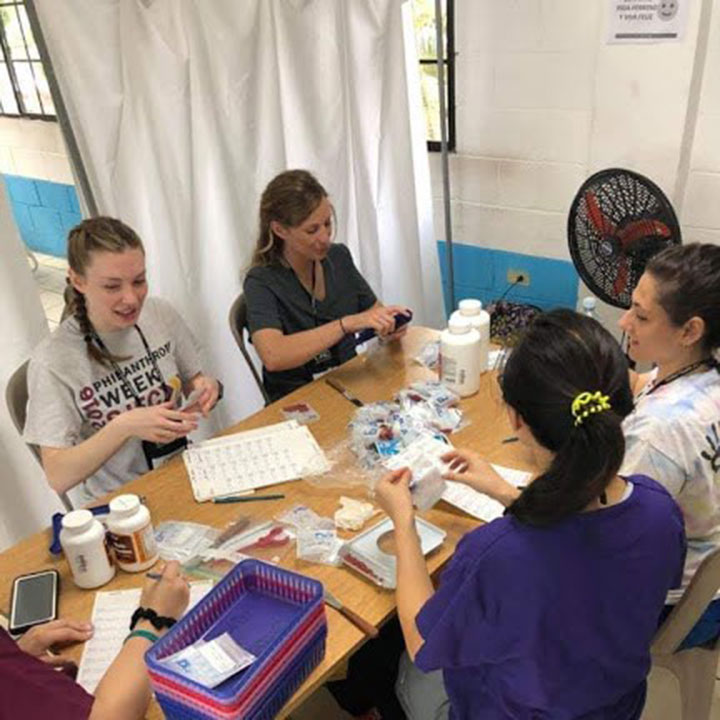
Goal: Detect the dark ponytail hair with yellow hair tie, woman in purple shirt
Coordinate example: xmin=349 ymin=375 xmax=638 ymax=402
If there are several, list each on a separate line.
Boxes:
xmin=501 ymin=310 xmax=633 ymax=525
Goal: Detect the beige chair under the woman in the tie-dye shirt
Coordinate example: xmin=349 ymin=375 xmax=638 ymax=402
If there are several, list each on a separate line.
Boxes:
xmin=648 ymin=548 xmax=720 ymax=720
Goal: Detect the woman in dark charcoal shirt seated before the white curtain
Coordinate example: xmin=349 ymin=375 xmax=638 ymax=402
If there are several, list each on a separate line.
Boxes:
xmin=243 ymin=170 xmax=407 ymax=400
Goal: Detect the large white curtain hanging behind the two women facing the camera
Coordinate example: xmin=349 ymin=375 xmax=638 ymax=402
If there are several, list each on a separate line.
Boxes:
xmin=35 ymin=0 xmax=443 ymax=424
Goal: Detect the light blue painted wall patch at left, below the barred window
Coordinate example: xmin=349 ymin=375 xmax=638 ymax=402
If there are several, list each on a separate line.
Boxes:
xmin=2 ymin=175 xmax=82 ymax=257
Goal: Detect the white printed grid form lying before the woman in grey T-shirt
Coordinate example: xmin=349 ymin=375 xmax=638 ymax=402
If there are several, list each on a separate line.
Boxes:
xmin=183 ymin=420 xmax=330 ymax=502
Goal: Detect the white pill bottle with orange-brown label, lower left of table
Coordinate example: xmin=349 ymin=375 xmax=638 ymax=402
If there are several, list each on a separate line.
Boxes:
xmin=107 ymin=495 xmax=158 ymax=572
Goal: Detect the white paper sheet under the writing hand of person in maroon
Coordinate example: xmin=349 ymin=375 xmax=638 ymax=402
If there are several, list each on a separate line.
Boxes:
xmin=77 ymin=582 xmax=212 ymax=694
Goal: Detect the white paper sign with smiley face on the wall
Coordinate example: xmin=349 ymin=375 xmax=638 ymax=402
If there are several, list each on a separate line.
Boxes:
xmin=607 ymin=0 xmax=690 ymax=43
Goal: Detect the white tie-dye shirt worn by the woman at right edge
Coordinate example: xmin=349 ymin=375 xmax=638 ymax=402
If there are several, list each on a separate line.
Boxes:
xmin=620 ymin=369 xmax=720 ymax=603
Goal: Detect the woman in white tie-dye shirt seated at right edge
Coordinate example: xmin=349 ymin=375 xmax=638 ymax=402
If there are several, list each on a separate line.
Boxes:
xmin=620 ymin=243 xmax=720 ymax=646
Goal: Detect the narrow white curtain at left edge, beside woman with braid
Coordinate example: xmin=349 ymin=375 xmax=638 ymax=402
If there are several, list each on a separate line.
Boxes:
xmin=0 ymin=178 xmax=63 ymax=552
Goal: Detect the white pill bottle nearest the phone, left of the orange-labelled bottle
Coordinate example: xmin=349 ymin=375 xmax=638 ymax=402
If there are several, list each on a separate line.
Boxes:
xmin=60 ymin=510 xmax=115 ymax=589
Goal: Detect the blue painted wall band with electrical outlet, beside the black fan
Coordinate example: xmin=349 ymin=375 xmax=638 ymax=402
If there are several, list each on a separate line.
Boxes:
xmin=438 ymin=240 xmax=578 ymax=318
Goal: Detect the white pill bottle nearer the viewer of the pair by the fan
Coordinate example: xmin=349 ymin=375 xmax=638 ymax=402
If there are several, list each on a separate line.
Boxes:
xmin=440 ymin=313 xmax=480 ymax=397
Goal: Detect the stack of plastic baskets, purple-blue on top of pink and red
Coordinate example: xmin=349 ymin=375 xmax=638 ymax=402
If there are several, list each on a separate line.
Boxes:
xmin=145 ymin=560 xmax=327 ymax=718
